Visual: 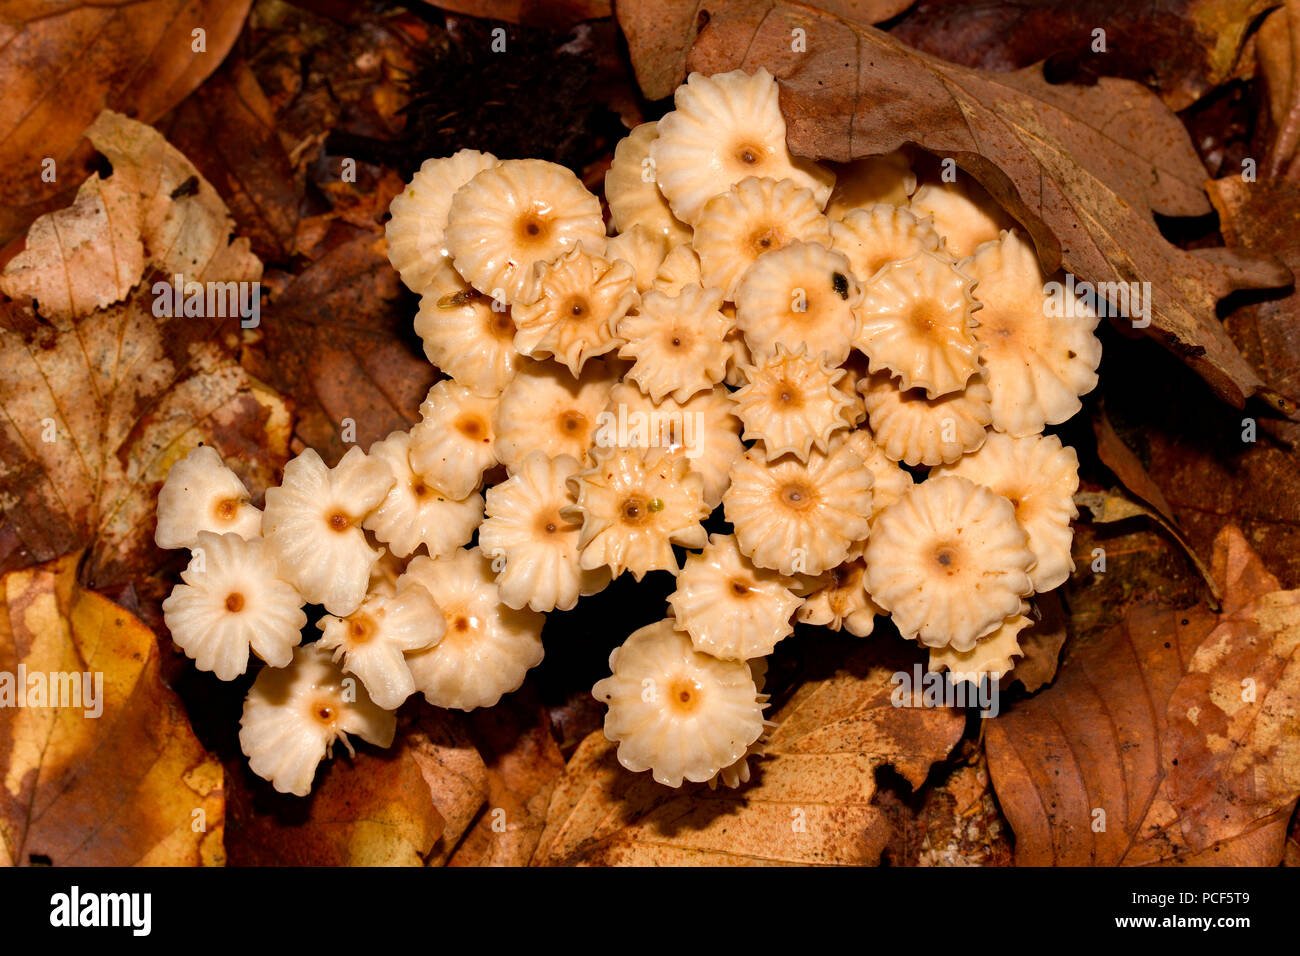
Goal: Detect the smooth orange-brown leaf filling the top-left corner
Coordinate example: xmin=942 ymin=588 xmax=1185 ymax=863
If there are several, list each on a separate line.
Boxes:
xmin=0 ymin=0 xmax=251 ymax=245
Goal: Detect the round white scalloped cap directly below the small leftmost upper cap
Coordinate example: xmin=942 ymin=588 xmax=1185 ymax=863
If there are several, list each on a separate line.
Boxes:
xmin=163 ymin=531 xmax=307 ymax=680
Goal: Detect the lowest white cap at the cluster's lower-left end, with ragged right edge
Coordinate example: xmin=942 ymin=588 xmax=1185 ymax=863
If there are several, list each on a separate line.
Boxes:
xmin=239 ymin=644 xmax=397 ymax=796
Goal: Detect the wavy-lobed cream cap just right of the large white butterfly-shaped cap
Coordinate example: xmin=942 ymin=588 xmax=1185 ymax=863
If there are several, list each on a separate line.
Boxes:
xmin=363 ymin=432 xmax=484 ymax=558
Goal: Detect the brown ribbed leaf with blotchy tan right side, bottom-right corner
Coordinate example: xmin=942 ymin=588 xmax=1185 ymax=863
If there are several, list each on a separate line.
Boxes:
xmin=985 ymin=525 xmax=1300 ymax=866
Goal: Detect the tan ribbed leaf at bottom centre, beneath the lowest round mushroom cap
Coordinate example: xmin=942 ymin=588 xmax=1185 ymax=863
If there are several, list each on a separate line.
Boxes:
xmin=533 ymin=645 xmax=966 ymax=866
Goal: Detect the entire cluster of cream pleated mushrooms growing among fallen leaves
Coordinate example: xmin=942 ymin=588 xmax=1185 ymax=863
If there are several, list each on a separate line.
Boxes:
xmin=157 ymin=69 xmax=1101 ymax=793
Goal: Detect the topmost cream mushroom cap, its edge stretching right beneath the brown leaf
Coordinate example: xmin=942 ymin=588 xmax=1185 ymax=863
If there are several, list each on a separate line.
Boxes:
xmin=650 ymin=68 xmax=835 ymax=225
